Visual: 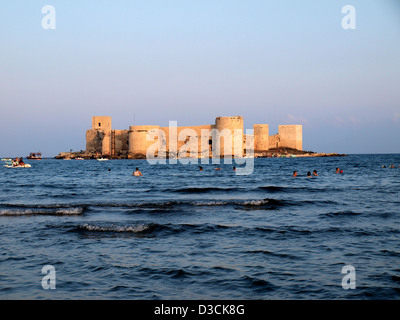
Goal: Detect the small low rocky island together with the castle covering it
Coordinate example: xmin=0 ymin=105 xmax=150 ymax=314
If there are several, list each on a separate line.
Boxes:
xmin=55 ymin=116 xmax=345 ymax=159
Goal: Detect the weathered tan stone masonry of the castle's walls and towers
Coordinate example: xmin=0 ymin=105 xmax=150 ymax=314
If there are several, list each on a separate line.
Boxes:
xmin=85 ymin=116 xmax=303 ymax=159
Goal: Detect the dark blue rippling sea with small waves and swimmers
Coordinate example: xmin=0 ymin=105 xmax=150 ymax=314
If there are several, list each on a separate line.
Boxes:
xmin=0 ymin=154 xmax=400 ymax=300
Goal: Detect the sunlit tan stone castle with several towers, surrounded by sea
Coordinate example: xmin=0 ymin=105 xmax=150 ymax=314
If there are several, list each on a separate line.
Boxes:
xmin=85 ymin=116 xmax=303 ymax=159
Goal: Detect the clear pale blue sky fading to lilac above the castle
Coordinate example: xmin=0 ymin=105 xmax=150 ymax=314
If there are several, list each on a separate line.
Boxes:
xmin=0 ymin=0 xmax=400 ymax=157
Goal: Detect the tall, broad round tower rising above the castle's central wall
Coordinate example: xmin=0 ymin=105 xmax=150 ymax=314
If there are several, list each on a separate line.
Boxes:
xmin=212 ymin=116 xmax=243 ymax=156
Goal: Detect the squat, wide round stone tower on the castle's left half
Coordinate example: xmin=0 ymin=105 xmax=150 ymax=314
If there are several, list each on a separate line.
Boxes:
xmin=128 ymin=126 xmax=160 ymax=159
